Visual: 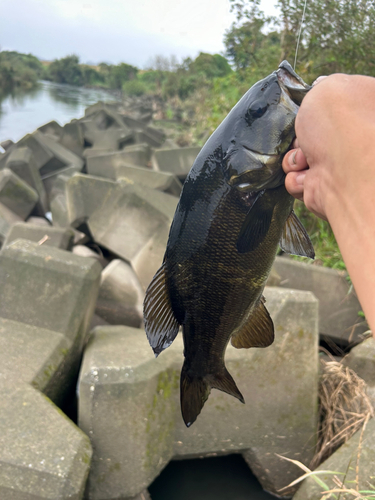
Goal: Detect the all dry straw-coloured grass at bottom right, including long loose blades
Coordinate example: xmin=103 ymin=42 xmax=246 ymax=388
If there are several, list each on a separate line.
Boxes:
xmin=278 ymin=359 xmax=375 ymax=500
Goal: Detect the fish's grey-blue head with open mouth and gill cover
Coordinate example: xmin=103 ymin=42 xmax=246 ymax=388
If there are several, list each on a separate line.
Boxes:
xmin=222 ymin=61 xmax=311 ymax=191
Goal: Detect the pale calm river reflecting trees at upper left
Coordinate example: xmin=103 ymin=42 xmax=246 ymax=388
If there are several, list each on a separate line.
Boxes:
xmin=0 ymin=81 xmax=120 ymax=142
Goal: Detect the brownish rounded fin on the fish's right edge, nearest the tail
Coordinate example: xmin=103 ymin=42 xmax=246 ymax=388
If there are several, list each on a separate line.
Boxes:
xmin=231 ymin=297 xmax=275 ymax=349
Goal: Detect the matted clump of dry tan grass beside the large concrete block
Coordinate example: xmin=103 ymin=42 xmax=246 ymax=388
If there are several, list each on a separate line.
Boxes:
xmin=310 ymin=359 xmax=374 ymax=469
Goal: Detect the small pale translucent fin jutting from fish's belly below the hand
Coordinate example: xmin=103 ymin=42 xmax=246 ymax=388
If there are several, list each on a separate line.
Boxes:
xmin=280 ymin=210 xmax=315 ymax=259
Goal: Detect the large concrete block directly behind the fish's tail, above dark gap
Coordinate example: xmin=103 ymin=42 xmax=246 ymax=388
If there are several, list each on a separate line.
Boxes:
xmin=79 ymin=288 xmax=318 ymax=500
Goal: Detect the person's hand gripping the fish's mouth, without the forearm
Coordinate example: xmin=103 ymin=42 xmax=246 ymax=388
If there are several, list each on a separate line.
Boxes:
xmin=283 ymin=74 xmax=375 ymax=225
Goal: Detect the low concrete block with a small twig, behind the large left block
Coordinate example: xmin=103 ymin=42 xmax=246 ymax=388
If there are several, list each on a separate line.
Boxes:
xmin=4 ymin=222 xmax=74 ymax=250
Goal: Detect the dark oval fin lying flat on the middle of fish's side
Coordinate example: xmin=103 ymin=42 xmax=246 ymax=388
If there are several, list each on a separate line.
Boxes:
xmin=237 ymin=191 xmax=274 ymax=253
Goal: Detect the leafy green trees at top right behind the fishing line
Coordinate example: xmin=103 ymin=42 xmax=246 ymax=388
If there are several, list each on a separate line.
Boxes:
xmin=224 ymin=0 xmax=375 ymax=78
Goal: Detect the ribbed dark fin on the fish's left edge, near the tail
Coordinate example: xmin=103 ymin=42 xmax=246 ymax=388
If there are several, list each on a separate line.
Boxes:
xmin=143 ymin=264 xmax=179 ymax=357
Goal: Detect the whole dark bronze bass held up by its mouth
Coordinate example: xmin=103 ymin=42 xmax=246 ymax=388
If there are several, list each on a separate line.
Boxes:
xmin=144 ymin=61 xmax=314 ymax=427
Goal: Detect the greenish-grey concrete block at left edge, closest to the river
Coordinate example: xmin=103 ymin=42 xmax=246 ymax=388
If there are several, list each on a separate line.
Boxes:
xmin=0 ymin=168 xmax=39 ymax=220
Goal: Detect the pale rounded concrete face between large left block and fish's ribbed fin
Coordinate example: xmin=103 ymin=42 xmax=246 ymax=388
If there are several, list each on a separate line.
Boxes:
xmin=95 ymin=259 xmax=144 ymax=328
